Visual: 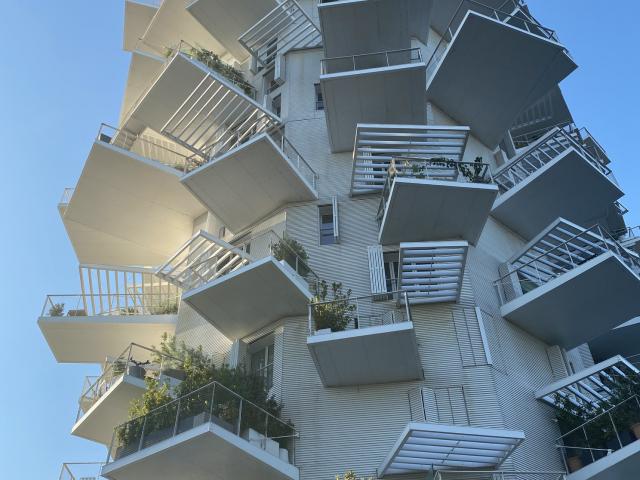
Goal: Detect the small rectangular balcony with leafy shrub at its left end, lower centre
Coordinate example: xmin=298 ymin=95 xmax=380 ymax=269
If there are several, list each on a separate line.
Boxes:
xmin=307 ymin=292 xmax=422 ymax=387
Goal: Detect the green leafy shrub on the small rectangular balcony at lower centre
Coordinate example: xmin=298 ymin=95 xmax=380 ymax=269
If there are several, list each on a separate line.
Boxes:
xmin=312 ymin=280 xmax=356 ymax=332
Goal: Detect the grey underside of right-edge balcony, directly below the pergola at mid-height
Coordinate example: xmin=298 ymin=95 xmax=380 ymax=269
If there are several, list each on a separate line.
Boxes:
xmin=501 ymin=252 xmax=640 ymax=349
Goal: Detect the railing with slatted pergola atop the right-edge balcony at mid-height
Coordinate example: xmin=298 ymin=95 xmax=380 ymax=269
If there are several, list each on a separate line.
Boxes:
xmin=496 ymin=219 xmax=640 ymax=304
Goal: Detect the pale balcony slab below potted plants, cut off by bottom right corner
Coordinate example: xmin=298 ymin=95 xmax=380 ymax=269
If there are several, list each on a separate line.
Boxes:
xmin=567 ymin=441 xmax=640 ymax=480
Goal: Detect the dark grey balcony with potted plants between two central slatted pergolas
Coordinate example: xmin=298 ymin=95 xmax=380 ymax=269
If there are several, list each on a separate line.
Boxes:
xmin=377 ymin=157 xmax=498 ymax=245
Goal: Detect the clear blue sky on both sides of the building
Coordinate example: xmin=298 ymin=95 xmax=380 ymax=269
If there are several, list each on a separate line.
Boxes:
xmin=0 ymin=0 xmax=640 ymax=479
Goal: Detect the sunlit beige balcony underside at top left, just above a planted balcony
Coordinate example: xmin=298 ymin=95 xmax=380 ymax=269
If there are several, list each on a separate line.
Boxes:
xmin=142 ymin=0 xmax=226 ymax=56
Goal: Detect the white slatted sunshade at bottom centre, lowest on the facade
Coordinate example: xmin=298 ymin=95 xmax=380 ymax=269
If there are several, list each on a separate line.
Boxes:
xmin=378 ymin=422 xmax=525 ymax=477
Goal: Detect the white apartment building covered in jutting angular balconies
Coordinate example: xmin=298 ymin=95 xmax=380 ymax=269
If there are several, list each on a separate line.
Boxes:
xmin=43 ymin=0 xmax=640 ymax=480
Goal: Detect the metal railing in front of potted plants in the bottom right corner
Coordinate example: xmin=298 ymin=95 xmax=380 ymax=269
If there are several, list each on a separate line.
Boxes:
xmin=556 ymin=395 xmax=640 ymax=473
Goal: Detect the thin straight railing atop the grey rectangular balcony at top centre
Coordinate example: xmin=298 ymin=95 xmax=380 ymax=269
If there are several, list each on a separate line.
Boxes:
xmin=320 ymin=48 xmax=422 ymax=75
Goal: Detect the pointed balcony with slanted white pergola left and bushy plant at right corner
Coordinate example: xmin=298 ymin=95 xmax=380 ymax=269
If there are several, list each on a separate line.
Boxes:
xmin=158 ymin=230 xmax=318 ymax=339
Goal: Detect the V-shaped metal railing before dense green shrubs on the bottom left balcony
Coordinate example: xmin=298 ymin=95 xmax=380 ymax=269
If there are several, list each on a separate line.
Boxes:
xmin=107 ymin=382 xmax=299 ymax=465
